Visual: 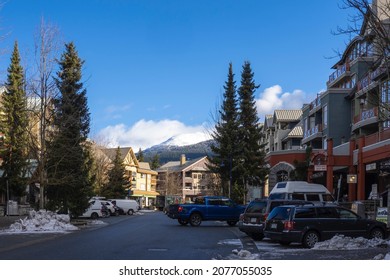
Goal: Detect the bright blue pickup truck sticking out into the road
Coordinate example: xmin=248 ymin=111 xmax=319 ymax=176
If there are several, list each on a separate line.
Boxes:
xmin=167 ymin=196 xmax=245 ymax=226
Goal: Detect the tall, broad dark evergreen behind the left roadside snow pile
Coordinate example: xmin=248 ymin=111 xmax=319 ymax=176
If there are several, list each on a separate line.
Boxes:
xmin=46 ymin=43 xmax=92 ymax=216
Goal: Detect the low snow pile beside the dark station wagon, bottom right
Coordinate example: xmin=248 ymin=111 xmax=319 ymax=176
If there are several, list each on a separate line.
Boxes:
xmin=313 ymin=235 xmax=390 ymax=250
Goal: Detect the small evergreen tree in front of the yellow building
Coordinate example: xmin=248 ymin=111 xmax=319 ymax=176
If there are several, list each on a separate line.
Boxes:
xmin=101 ymin=147 xmax=130 ymax=198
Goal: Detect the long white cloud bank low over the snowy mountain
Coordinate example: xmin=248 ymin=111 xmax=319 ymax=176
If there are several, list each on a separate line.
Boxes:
xmin=96 ymin=119 xmax=212 ymax=152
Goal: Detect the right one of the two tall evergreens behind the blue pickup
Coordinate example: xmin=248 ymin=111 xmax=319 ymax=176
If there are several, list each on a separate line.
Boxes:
xmin=238 ymin=62 xmax=267 ymax=202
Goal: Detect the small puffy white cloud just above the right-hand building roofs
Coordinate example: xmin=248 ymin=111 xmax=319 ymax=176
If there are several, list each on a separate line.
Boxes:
xmin=256 ymin=85 xmax=308 ymax=118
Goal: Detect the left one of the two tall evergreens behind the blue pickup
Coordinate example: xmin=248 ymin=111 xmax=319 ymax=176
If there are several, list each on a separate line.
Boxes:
xmin=208 ymin=63 xmax=238 ymax=199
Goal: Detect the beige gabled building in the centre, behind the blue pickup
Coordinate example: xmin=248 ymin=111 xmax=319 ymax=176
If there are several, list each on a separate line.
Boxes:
xmin=157 ymin=154 xmax=221 ymax=201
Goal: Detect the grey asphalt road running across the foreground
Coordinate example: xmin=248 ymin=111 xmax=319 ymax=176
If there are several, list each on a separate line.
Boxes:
xmin=0 ymin=212 xmax=390 ymax=260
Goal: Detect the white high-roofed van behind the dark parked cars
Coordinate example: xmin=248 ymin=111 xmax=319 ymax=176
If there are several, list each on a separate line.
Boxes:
xmin=268 ymin=181 xmax=335 ymax=203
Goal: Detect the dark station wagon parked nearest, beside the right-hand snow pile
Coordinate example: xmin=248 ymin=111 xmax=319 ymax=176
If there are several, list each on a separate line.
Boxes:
xmin=264 ymin=205 xmax=388 ymax=248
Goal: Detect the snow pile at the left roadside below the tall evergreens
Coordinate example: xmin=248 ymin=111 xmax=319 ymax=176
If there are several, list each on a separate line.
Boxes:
xmin=7 ymin=210 xmax=78 ymax=233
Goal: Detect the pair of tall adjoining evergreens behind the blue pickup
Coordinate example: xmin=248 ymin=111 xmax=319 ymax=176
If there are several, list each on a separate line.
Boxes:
xmin=209 ymin=61 xmax=268 ymax=203
